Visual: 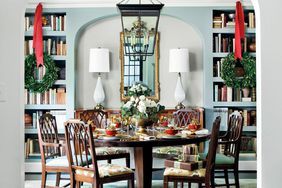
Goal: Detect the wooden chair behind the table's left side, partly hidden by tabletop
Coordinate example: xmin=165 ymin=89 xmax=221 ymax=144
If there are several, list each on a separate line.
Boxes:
xmin=78 ymin=109 xmax=130 ymax=167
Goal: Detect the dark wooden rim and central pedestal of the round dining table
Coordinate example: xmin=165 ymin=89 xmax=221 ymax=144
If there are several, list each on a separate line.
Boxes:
xmin=95 ymin=134 xmax=210 ymax=188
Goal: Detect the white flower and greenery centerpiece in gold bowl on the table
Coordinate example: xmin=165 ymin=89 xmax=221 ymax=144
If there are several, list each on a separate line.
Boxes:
xmin=121 ymin=84 xmax=165 ymax=131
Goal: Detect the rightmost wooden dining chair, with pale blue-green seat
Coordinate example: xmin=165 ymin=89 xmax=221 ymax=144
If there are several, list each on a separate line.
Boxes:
xmin=215 ymin=111 xmax=243 ymax=188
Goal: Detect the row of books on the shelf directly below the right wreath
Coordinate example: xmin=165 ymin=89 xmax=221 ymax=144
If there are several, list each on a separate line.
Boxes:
xmin=214 ymin=84 xmax=256 ymax=102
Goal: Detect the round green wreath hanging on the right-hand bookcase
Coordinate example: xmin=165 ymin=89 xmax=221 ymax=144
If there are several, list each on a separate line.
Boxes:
xmin=221 ymin=53 xmax=256 ymax=88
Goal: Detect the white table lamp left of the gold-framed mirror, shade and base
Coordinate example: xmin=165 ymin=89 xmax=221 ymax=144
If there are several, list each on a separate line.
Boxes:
xmin=89 ymin=48 xmax=110 ymax=109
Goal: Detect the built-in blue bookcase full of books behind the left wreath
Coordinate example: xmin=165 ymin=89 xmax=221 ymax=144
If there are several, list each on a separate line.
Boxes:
xmin=24 ymin=9 xmax=69 ymax=173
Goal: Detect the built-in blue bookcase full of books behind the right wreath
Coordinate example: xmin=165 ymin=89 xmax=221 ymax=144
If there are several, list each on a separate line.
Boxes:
xmin=210 ymin=8 xmax=256 ymax=170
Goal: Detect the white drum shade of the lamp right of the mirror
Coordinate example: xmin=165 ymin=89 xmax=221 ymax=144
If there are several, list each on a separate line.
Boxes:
xmin=169 ymin=48 xmax=189 ymax=72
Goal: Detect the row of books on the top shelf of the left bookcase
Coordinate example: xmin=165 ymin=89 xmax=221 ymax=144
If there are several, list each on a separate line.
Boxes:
xmin=24 ymin=15 xmax=67 ymax=31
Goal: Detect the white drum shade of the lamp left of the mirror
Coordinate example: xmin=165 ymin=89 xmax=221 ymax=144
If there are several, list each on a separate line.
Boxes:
xmin=89 ymin=48 xmax=110 ymax=72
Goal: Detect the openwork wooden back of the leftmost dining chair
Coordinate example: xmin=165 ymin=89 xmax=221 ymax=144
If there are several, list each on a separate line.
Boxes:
xmin=38 ymin=113 xmax=61 ymax=164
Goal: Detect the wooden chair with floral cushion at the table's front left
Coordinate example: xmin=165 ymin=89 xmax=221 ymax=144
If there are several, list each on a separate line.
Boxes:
xmin=65 ymin=119 xmax=134 ymax=188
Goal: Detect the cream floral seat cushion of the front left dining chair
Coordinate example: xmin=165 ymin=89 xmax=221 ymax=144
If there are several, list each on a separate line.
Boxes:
xmin=75 ymin=164 xmax=133 ymax=178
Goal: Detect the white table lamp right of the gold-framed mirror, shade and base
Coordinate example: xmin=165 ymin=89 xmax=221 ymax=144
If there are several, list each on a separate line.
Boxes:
xmin=169 ymin=48 xmax=189 ymax=109
